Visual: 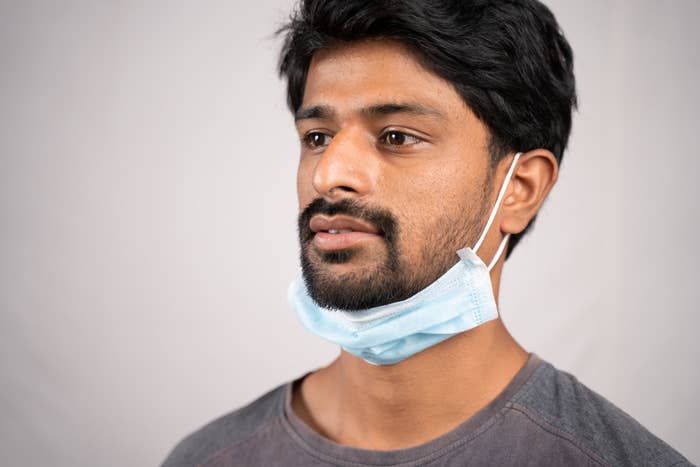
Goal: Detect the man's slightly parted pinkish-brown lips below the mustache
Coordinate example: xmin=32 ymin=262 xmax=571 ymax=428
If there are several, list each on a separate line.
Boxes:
xmin=309 ymin=215 xmax=380 ymax=251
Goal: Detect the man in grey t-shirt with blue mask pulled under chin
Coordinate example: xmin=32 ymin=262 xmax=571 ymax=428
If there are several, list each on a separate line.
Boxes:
xmin=164 ymin=0 xmax=689 ymax=466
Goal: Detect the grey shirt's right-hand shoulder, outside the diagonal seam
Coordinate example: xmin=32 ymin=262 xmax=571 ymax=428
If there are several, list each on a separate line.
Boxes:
xmin=510 ymin=362 xmax=691 ymax=466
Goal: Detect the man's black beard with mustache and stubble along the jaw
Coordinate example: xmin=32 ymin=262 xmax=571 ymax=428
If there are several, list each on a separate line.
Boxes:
xmin=298 ymin=176 xmax=492 ymax=311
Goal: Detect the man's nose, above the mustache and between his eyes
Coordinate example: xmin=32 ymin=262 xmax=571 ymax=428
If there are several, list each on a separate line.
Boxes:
xmin=312 ymin=128 xmax=379 ymax=201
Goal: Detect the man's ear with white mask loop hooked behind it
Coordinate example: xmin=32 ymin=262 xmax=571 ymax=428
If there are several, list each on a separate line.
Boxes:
xmin=500 ymin=149 xmax=559 ymax=234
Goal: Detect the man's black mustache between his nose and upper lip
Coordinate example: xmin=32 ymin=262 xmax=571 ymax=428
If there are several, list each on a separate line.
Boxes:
xmin=297 ymin=198 xmax=398 ymax=245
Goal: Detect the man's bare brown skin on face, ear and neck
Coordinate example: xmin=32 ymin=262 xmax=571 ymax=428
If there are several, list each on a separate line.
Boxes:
xmin=292 ymin=41 xmax=558 ymax=450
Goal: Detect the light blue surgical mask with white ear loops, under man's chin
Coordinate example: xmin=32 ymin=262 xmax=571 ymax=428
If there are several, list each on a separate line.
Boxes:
xmin=288 ymin=153 xmax=521 ymax=365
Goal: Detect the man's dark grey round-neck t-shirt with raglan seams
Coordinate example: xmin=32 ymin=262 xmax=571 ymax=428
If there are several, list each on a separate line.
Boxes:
xmin=163 ymin=354 xmax=692 ymax=467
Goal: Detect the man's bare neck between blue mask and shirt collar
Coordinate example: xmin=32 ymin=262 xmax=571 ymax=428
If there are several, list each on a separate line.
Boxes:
xmin=293 ymin=319 xmax=527 ymax=450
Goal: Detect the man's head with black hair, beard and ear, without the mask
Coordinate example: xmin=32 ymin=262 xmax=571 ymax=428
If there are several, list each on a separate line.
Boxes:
xmin=280 ymin=0 xmax=575 ymax=309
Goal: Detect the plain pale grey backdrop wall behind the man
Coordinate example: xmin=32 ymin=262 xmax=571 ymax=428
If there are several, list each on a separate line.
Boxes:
xmin=0 ymin=0 xmax=700 ymax=466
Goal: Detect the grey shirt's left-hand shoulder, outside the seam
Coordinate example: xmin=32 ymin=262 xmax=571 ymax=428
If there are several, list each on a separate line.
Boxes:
xmin=162 ymin=384 xmax=288 ymax=467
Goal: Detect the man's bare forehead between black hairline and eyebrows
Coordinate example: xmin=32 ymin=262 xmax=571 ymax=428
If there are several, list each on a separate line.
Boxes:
xmin=302 ymin=39 xmax=468 ymax=115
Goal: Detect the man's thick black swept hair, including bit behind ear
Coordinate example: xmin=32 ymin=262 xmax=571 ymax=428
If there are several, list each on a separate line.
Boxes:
xmin=279 ymin=0 xmax=576 ymax=255
